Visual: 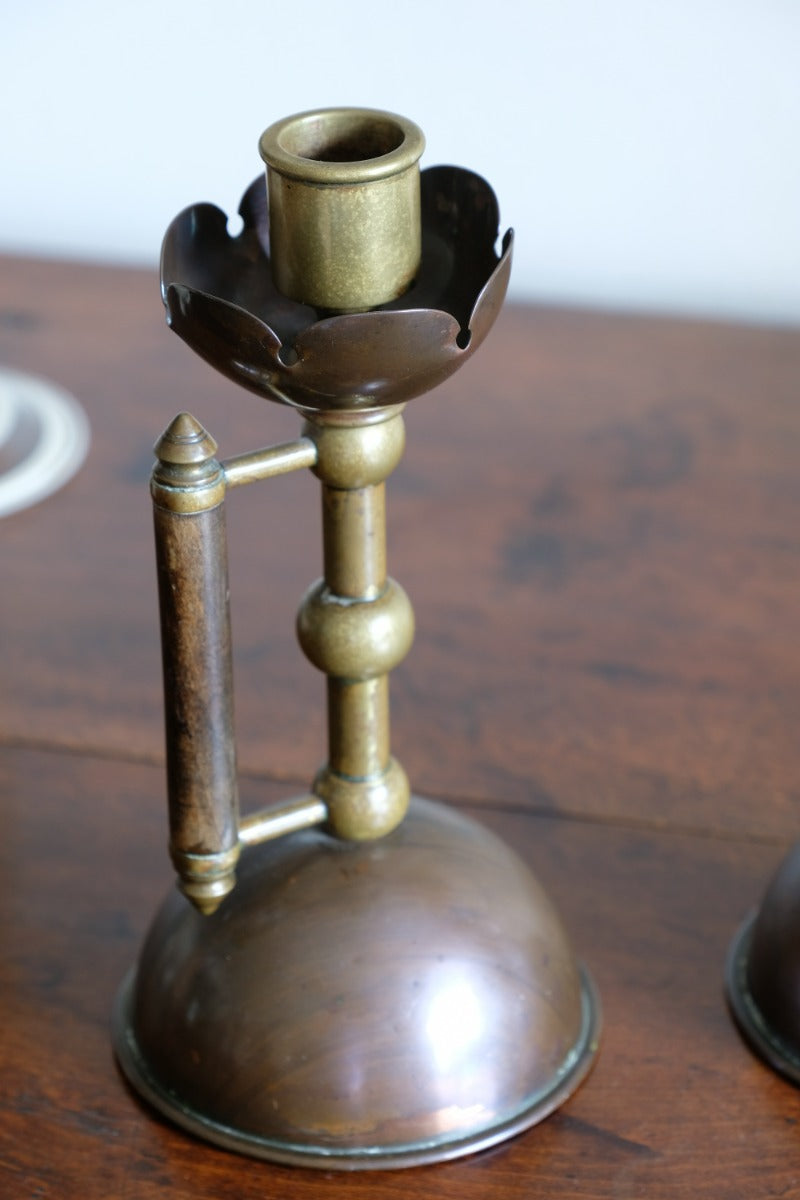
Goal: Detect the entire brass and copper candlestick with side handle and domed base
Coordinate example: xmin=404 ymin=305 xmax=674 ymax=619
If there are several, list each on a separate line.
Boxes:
xmin=114 ymin=109 xmax=599 ymax=1169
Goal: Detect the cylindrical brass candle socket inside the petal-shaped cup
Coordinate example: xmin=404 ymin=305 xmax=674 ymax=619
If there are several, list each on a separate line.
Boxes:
xmin=259 ymin=108 xmax=425 ymax=312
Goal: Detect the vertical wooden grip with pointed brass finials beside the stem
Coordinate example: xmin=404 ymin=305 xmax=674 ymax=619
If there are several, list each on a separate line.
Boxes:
xmin=151 ymin=413 xmax=239 ymax=913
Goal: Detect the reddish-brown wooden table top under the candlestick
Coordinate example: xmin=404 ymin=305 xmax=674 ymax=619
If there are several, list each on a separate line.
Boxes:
xmin=0 ymin=250 xmax=800 ymax=1200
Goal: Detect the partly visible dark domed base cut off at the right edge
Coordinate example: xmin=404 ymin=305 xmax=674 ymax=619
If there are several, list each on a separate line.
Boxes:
xmin=726 ymin=844 xmax=800 ymax=1085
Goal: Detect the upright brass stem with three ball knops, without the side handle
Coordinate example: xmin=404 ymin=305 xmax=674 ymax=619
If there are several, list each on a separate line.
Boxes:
xmin=297 ymin=409 xmax=414 ymax=840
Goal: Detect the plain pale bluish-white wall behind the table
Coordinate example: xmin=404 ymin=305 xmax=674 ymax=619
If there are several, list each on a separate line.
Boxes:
xmin=0 ymin=0 xmax=800 ymax=323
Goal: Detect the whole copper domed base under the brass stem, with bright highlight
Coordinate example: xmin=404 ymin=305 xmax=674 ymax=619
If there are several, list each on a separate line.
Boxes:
xmin=114 ymin=799 xmax=600 ymax=1170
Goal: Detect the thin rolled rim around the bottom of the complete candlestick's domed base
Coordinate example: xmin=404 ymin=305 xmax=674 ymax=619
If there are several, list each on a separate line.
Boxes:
xmin=112 ymin=964 xmax=602 ymax=1171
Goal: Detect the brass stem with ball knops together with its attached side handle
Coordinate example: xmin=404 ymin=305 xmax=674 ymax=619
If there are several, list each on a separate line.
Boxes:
xmin=151 ymin=406 xmax=414 ymax=914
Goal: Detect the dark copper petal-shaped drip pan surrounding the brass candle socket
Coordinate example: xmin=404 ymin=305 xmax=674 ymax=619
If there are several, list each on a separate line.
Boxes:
xmin=161 ymin=167 xmax=512 ymax=412
